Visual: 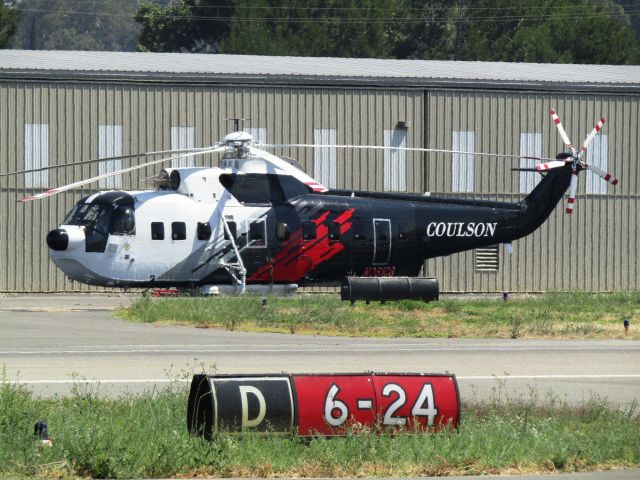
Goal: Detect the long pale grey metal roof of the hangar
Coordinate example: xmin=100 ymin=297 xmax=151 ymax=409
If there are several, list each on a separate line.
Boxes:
xmin=0 ymin=50 xmax=640 ymax=92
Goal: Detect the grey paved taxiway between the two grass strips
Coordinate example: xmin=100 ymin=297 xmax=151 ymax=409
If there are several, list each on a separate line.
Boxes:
xmin=0 ymin=295 xmax=640 ymax=404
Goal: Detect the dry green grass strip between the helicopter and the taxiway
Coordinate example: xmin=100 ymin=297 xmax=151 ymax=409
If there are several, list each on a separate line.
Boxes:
xmin=118 ymin=292 xmax=640 ymax=339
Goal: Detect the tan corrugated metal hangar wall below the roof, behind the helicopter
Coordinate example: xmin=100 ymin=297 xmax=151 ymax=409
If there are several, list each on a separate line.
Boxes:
xmin=0 ymin=82 xmax=640 ymax=292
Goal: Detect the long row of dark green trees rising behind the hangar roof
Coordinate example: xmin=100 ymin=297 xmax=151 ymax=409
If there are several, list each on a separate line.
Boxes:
xmin=136 ymin=0 xmax=640 ymax=64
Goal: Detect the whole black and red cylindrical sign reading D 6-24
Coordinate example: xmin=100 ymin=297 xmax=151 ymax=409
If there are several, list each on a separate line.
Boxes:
xmin=187 ymin=373 xmax=460 ymax=438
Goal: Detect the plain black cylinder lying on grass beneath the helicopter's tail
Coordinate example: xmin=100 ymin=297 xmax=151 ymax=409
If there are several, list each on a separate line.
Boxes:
xmin=340 ymin=277 xmax=440 ymax=302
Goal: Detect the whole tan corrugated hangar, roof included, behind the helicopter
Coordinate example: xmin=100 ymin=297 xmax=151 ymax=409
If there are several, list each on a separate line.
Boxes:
xmin=0 ymin=50 xmax=640 ymax=292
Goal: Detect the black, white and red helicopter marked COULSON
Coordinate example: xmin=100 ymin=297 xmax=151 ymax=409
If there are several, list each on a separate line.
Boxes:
xmin=4 ymin=110 xmax=618 ymax=293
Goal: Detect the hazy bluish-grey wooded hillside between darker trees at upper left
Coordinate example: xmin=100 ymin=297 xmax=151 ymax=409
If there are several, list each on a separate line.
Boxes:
xmin=15 ymin=0 xmax=138 ymax=51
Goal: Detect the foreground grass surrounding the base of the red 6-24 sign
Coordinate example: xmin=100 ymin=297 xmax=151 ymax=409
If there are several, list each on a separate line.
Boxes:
xmin=0 ymin=381 xmax=640 ymax=478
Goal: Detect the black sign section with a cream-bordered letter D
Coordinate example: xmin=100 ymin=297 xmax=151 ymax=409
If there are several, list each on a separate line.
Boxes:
xmin=210 ymin=375 xmax=294 ymax=433
